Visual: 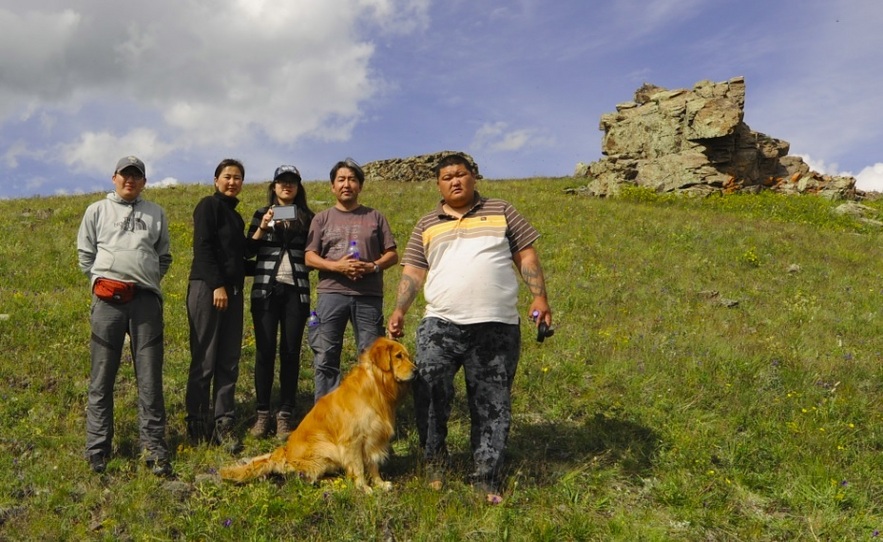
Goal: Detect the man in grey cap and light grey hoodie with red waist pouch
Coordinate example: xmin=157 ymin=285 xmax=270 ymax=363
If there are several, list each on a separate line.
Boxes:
xmin=77 ymin=156 xmax=172 ymax=476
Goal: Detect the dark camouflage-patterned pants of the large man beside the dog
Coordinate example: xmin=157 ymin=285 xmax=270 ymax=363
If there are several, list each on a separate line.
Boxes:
xmin=414 ymin=317 xmax=521 ymax=484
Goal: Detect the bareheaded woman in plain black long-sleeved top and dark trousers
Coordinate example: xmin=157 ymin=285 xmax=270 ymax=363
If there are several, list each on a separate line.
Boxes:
xmin=185 ymin=158 xmax=248 ymax=452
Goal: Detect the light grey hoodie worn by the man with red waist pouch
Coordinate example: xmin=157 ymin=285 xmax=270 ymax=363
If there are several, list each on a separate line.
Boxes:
xmin=77 ymin=192 xmax=172 ymax=296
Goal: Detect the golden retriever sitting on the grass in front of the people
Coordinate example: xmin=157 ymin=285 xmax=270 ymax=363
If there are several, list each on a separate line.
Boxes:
xmin=220 ymin=337 xmax=416 ymax=493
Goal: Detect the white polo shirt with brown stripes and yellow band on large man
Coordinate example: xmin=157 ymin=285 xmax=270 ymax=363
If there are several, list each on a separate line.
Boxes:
xmin=402 ymin=192 xmax=540 ymax=324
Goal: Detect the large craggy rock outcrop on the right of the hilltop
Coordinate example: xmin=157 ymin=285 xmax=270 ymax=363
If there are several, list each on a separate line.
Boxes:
xmin=575 ymin=77 xmax=856 ymax=199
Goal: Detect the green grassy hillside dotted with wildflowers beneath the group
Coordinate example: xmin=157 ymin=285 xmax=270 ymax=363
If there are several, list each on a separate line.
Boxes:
xmin=0 ymin=178 xmax=883 ymax=541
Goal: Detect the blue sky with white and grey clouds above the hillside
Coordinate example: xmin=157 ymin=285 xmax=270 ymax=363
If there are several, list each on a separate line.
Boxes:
xmin=0 ymin=0 xmax=883 ymax=198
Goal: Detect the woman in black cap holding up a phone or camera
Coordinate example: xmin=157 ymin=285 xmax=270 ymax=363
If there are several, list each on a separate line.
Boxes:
xmin=247 ymin=166 xmax=313 ymax=439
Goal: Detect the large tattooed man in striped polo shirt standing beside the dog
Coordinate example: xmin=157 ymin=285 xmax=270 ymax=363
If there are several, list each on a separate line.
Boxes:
xmin=387 ymin=154 xmax=552 ymax=503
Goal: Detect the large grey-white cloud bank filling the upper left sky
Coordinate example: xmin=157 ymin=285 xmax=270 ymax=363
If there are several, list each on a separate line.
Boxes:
xmin=0 ymin=0 xmax=429 ymax=178
